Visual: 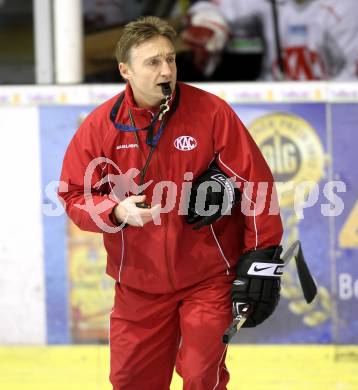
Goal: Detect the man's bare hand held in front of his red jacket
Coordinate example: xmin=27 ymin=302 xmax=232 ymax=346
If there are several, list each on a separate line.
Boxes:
xmin=113 ymin=195 xmax=160 ymax=227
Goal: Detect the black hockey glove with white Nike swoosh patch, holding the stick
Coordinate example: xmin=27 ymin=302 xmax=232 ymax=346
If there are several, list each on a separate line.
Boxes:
xmin=231 ymin=246 xmax=284 ymax=328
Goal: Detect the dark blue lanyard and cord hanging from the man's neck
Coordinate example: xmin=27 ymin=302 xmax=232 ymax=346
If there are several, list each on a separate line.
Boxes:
xmin=110 ymin=85 xmax=180 ymax=187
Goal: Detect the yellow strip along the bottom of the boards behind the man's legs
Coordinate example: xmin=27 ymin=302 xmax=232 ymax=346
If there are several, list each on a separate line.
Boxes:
xmin=0 ymin=345 xmax=358 ymax=390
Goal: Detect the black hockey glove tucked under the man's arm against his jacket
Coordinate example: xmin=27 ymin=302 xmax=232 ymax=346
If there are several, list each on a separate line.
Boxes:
xmin=186 ymin=164 xmax=240 ymax=230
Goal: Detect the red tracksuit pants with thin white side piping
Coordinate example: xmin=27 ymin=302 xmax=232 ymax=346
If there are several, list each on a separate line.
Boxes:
xmin=110 ymin=275 xmax=234 ymax=390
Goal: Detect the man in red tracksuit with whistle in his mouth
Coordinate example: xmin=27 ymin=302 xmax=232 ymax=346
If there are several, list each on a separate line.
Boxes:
xmin=60 ymin=17 xmax=282 ymax=390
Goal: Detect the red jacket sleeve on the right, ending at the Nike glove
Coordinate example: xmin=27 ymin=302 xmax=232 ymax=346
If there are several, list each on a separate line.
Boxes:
xmin=214 ymin=102 xmax=283 ymax=252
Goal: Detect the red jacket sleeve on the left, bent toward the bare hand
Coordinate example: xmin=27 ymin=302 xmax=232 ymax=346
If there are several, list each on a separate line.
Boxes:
xmin=58 ymin=110 xmax=118 ymax=232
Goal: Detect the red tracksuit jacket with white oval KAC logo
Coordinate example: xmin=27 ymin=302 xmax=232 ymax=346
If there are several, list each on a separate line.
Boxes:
xmin=59 ymin=83 xmax=282 ymax=293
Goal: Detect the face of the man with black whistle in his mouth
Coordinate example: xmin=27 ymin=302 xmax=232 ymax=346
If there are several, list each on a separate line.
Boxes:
xmin=119 ymin=35 xmax=177 ymax=107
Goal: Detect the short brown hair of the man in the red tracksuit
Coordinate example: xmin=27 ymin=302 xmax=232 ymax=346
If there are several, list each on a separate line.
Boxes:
xmin=116 ymin=16 xmax=176 ymax=63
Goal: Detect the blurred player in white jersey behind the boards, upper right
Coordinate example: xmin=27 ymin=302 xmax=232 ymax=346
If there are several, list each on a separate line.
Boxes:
xmin=183 ymin=0 xmax=358 ymax=81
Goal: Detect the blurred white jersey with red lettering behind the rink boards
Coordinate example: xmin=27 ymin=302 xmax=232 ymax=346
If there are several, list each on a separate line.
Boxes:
xmin=193 ymin=0 xmax=358 ymax=80
